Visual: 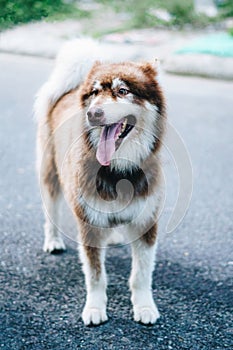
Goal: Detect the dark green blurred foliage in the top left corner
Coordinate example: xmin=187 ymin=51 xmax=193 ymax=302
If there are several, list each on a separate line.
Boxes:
xmin=0 ymin=0 xmax=86 ymax=29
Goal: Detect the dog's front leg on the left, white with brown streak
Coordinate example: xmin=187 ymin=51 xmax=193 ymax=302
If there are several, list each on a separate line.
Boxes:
xmin=79 ymin=229 xmax=107 ymax=325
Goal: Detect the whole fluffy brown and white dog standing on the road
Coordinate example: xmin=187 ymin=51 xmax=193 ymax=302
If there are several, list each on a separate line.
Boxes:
xmin=35 ymin=40 xmax=166 ymax=325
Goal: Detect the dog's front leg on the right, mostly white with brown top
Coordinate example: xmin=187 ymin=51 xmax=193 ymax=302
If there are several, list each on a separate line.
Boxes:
xmin=130 ymin=225 xmax=159 ymax=324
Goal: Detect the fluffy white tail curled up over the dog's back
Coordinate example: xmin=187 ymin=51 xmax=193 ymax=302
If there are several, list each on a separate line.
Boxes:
xmin=34 ymin=38 xmax=101 ymax=121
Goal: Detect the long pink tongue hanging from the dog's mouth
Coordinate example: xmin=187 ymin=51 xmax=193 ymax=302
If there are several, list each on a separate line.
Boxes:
xmin=96 ymin=123 xmax=121 ymax=166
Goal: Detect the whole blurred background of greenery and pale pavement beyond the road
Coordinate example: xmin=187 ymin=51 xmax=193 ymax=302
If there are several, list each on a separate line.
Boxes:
xmin=0 ymin=0 xmax=233 ymax=79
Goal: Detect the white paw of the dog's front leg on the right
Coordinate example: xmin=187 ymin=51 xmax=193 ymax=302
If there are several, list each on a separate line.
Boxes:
xmin=134 ymin=305 xmax=160 ymax=324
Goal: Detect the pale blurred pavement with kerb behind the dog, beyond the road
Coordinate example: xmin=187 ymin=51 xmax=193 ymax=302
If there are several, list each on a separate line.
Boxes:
xmin=0 ymin=20 xmax=233 ymax=80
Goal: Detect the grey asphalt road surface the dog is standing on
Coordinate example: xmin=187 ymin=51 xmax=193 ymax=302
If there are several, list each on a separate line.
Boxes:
xmin=0 ymin=54 xmax=233 ymax=350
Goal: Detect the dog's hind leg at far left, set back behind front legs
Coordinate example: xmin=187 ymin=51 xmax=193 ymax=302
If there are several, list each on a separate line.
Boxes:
xmin=37 ymin=124 xmax=65 ymax=253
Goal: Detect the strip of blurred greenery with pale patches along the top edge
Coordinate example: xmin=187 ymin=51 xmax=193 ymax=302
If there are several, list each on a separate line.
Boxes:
xmin=0 ymin=0 xmax=233 ymax=36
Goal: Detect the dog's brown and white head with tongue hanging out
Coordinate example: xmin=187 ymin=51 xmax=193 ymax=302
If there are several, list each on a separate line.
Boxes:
xmin=81 ymin=62 xmax=165 ymax=166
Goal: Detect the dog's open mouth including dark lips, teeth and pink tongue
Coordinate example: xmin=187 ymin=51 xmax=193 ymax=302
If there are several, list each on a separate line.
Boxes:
xmin=96 ymin=114 xmax=136 ymax=166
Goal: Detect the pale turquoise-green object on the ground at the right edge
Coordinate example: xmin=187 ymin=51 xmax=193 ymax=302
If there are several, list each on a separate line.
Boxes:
xmin=176 ymin=33 xmax=233 ymax=57
